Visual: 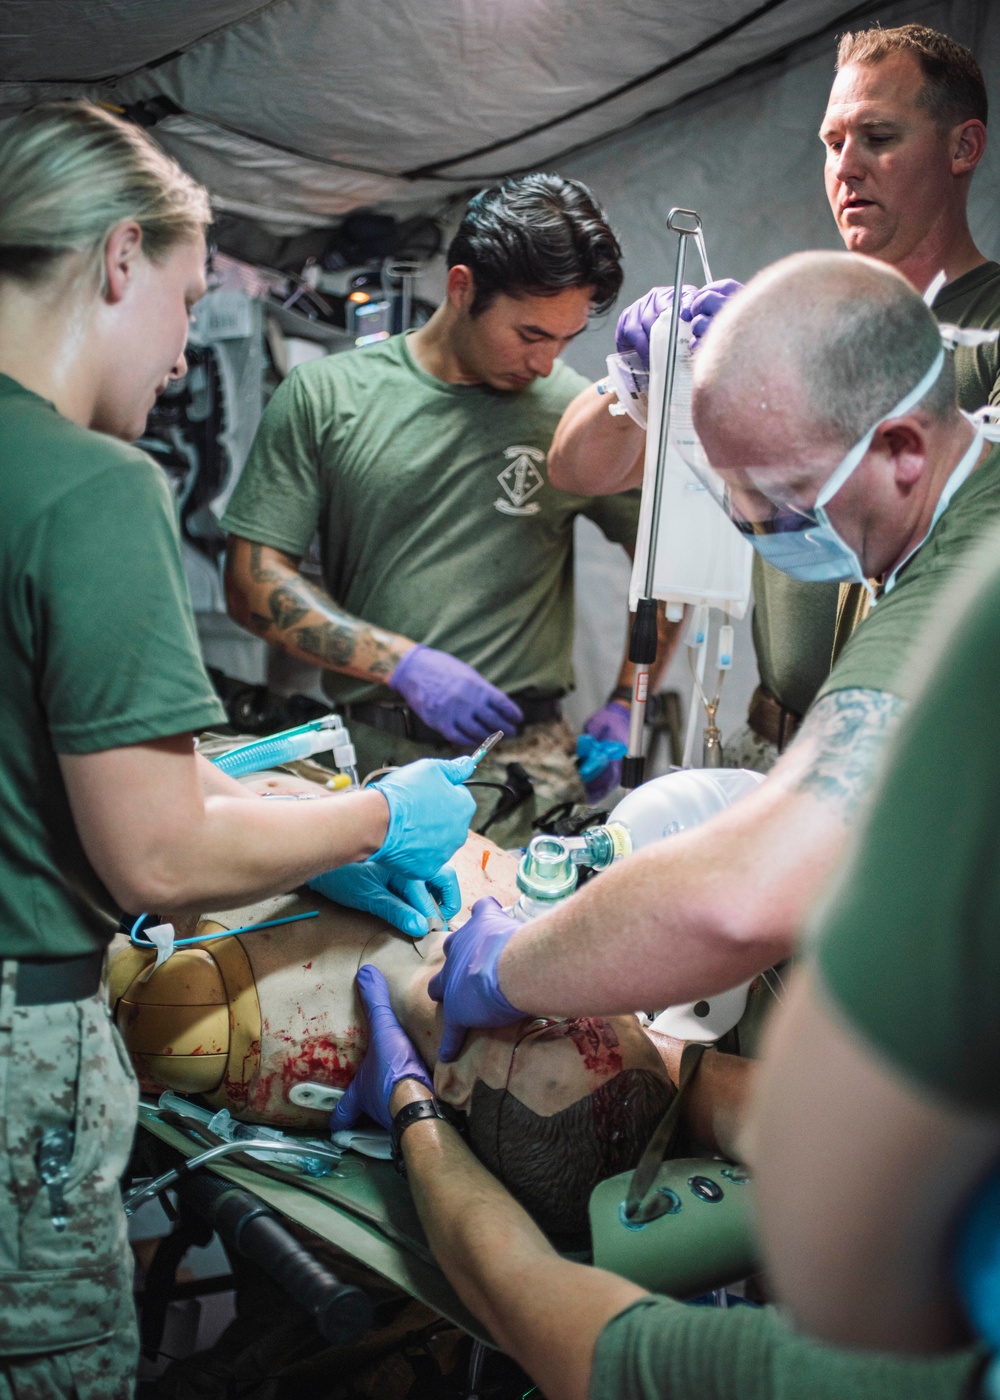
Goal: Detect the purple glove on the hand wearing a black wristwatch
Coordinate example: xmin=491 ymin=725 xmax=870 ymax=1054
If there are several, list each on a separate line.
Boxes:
xmin=331 ymin=963 xmax=434 ymax=1133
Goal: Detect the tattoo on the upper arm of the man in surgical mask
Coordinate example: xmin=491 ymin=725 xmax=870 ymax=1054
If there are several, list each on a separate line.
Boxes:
xmin=793 ymin=687 xmax=905 ymax=820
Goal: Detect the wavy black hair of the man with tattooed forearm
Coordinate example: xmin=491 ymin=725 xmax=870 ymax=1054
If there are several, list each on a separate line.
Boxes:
xmin=448 ymin=174 xmax=623 ymax=316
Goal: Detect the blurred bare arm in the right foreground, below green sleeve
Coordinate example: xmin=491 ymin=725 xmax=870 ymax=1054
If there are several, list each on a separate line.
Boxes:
xmin=745 ymin=968 xmax=1000 ymax=1352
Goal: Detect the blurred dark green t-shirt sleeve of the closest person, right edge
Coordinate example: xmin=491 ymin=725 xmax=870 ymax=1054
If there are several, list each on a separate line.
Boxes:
xmin=815 ymin=531 xmax=1000 ymax=1113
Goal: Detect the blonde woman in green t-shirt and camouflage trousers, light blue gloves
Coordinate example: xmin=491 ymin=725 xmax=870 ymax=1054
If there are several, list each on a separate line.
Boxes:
xmin=0 ymin=102 xmax=473 ymax=1400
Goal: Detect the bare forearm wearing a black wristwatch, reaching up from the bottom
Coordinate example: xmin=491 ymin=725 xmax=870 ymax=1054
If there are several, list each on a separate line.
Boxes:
xmin=389 ymin=1079 xmax=644 ymax=1400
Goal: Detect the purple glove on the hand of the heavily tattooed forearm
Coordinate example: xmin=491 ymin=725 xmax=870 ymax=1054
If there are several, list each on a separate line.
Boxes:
xmin=389 ymin=647 xmax=524 ymax=743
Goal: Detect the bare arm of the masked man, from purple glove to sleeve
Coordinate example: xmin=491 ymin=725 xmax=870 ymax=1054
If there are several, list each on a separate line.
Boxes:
xmin=499 ymin=689 xmax=902 ymax=1016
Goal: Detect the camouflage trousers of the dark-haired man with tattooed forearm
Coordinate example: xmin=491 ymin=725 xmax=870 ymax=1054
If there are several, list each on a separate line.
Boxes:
xmin=347 ymin=720 xmax=587 ymax=847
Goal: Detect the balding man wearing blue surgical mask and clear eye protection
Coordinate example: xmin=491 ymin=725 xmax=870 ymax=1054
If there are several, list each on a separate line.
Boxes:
xmin=430 ymin=253 xmax=1000 ymax=1058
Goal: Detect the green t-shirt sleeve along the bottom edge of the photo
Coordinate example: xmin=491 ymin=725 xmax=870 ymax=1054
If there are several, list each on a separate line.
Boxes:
xmin=590 ymin=1295 xmax=985 ymax=1400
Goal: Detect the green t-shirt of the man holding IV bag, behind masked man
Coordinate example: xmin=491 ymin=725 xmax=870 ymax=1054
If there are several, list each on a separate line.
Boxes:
xmin=754 ymin=262 xmax=1000 ymax=714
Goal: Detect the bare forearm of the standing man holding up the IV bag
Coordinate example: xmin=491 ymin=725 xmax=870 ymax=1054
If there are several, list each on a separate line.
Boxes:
xmin=548 ymin=385 xmax=646 ymax=496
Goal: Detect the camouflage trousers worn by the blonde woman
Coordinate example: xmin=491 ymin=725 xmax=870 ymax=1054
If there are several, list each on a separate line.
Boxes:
xmin=0 ymin=959 xmax=139 ymax=1400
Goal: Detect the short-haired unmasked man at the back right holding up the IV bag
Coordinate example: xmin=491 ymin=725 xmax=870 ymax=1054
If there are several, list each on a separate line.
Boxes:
xmin=550 ymin=24 xmax=1000 ymax=773
